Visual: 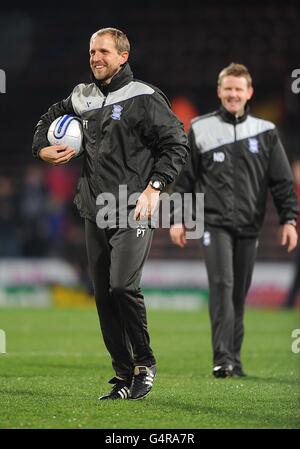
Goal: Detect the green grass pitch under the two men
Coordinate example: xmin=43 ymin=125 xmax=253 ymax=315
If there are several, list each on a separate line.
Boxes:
xmin=0 ymin=308 xmax=300 ymax=429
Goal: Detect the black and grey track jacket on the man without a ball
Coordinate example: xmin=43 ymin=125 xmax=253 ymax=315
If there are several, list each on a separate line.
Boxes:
xmin=173 ymin=106 xmax=297 ymax=236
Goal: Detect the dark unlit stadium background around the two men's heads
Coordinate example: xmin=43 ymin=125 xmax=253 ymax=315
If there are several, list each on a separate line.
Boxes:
xmin=0 ymin=0 xmax=300 ymax=162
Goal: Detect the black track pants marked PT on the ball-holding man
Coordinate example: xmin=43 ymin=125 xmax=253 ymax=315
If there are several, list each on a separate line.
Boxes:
xmin=85 ymin=220 xmax=155 ymax=377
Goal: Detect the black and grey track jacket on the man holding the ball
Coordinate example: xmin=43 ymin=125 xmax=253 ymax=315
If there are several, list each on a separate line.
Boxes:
xmin=32 ymin=63 xmax=189 ymax=221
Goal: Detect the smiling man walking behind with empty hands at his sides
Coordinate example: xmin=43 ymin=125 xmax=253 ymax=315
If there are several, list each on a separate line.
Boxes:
xmin=170 ymin=63 xmax=297 ymax=378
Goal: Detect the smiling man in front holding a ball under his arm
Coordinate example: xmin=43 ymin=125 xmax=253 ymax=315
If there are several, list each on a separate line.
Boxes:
xmin=33 ymin=28 xmax=189 ymax=400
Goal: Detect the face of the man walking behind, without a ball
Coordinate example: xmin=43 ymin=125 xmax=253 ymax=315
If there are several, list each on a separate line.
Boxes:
xmin=218 ymin=75 xmax=253 ymax=116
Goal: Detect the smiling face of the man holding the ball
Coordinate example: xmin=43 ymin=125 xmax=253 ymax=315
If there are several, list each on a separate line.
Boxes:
xmin=89 ymin=34 xmax=128 ymax=84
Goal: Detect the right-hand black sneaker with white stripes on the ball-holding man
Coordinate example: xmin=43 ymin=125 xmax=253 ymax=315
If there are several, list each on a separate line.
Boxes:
xmin=130 ymin=365 xmax=156 ymax=399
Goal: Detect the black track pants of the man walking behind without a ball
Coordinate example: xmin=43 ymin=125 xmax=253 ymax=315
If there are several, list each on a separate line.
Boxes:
xmin=203 ymin=226 xmax=257 ymax=367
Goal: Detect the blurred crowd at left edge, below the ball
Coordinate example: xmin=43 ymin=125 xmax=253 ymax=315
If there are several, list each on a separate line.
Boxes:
xmin=0 ymin=162 xmax=89 ymax=292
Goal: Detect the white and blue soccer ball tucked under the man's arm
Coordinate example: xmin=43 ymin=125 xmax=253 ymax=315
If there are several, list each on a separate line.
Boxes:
xmin=47 ymin=115 xmax=83 ymax=155
